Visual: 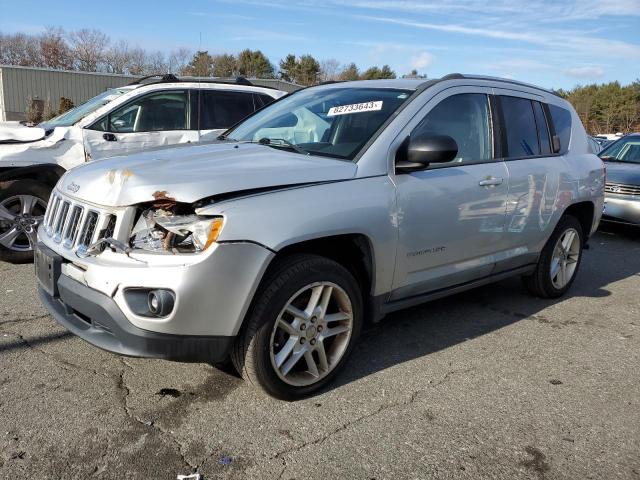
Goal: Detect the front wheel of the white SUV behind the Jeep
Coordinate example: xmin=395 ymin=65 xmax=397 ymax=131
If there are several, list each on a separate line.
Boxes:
xmin=0 ymin=180 xmax=51 ymax=263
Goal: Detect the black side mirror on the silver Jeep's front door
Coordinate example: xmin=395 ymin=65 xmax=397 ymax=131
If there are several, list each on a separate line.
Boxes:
xmin=396 ymin=133 xmax=458 ymax=172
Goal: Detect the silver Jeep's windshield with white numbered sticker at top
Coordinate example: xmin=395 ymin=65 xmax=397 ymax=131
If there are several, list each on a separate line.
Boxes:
xmin=225 ymin=88 xmax=412 ymax=160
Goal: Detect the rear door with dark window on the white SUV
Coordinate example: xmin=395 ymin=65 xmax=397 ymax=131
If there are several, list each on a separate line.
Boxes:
xmin=200 ymin=89 xmax=263 ymax=141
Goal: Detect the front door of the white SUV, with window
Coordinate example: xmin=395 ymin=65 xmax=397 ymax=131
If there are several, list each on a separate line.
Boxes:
xmin=83 ymin=90 xmax=199 ymax=160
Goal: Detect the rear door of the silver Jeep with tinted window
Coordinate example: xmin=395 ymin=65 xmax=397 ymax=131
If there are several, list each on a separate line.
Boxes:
xmin=495 ymin=89 xmax=568 ymax=270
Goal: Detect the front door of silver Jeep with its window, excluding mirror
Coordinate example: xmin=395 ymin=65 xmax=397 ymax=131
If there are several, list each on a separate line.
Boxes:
xmin=391 ymin=87 xmax=509 ymax=300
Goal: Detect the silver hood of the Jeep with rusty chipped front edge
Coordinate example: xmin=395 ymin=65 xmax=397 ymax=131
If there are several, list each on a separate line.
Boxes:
xmin=58 ymin=142 xmax=357 ymax=207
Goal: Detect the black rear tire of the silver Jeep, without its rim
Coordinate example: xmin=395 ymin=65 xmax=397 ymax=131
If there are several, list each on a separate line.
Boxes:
xmin=522 ymin=215 xmax=584 ymax=298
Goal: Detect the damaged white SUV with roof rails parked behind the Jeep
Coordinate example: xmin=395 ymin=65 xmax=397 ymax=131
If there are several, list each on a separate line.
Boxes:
xmin=0 ymin=75 xmax=285 ymax=263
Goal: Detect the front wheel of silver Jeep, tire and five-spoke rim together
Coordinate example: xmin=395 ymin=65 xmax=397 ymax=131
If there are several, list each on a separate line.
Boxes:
xmin=231 ymin=255 xmax=362 ymax=400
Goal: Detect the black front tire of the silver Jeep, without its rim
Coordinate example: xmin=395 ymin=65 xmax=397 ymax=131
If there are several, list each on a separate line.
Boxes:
xmin=231 ymin=254 xmax=363 ymax=400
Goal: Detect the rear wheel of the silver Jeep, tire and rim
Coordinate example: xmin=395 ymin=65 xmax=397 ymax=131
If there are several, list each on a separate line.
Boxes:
xmin=523 ymin=215 xmax=584 ymax=298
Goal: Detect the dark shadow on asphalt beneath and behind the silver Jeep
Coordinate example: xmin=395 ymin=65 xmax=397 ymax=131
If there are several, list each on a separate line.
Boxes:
xmin=327 ymin=226 xmax=640 ymax=390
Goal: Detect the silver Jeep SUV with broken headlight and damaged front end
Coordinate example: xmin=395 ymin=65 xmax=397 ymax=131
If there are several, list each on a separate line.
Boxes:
xmin=36 ymin=74 xmax=604 ymax=399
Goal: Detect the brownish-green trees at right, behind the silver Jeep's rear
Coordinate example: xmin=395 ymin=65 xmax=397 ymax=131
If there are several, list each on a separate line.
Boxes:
xmin=558 ymin=79 xmax=640 ymax=135
